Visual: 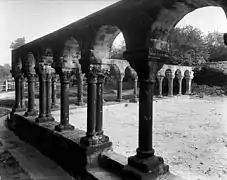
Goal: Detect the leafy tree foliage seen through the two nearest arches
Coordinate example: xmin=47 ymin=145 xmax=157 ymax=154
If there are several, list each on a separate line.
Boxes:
xmin=110 ymin=25 xmax=227 ymax=66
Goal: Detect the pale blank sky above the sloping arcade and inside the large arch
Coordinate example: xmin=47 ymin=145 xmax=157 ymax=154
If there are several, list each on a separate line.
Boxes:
xmin=0 ymin=0 xmax=227 ymax=65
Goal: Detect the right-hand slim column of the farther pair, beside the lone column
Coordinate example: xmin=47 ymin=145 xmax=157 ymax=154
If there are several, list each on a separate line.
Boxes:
xmin=45 ymin=65 xmax=54 ymax=121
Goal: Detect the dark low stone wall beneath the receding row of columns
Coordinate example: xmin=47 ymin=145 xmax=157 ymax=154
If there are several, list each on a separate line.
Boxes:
xmin=7 ymin=113 xmax=112 ymax=180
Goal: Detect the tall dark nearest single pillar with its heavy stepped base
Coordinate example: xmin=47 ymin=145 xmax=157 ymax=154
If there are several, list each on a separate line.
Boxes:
xmin=122 ymin=43 xmax=169 ymax=180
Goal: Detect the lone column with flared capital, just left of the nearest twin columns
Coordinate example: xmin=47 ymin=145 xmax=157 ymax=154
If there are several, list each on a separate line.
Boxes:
xmin=55 ymin=68 xmax=74 ymax=131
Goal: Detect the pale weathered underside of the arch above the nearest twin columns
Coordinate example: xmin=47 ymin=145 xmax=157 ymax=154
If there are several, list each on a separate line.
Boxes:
xmin=93 ymin=25 xmax=125 ymax=61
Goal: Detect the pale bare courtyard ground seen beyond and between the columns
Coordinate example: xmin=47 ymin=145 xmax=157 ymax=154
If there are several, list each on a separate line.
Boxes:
xmin=53 ymin=96 xmax=227 ymax=180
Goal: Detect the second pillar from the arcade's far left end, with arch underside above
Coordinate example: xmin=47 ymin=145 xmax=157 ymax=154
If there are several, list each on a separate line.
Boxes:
xmin=23 ymin=53 xmax=37 ymax=116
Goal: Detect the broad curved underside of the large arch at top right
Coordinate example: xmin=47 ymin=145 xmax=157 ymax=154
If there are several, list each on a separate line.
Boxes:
xmin=150 ymin=3 xmax=226 ymax=41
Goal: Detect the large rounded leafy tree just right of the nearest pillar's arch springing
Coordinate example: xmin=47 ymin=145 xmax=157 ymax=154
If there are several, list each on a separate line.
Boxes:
xmin=168 ymin=25 xmax=209 ymax=66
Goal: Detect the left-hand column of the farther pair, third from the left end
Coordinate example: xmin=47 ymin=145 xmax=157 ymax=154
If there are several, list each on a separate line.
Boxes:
xmin=35 ymin=63 xmax=47 ymax=123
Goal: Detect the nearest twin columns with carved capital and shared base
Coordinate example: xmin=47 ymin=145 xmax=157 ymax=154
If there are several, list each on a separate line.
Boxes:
xmin=80 ymin=65 xmax=112 ymax=152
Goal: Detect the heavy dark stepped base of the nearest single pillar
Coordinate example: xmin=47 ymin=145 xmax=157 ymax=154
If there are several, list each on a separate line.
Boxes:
xmin=122 ymin=155 xmax=169 ymax=180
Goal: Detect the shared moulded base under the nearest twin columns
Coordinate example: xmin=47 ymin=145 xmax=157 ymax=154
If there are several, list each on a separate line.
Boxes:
xmin=80 ymin=135 xmax=112 ymax=154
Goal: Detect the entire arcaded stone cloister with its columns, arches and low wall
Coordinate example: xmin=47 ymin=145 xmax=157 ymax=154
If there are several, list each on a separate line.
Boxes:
xmin=9 ymin=0 xmax=227 ymax=179
